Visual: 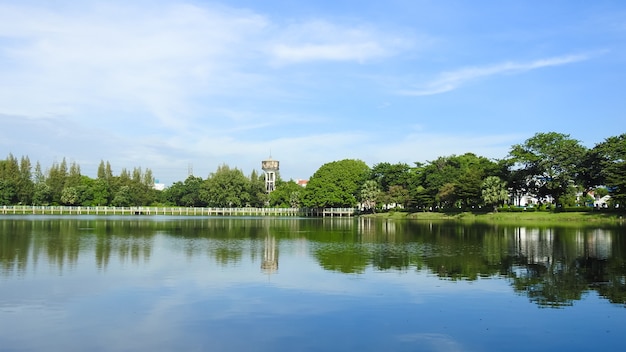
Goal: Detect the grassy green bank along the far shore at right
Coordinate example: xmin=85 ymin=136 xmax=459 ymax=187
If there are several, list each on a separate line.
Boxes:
xmin=364 ymin=212 xmax=626 ymax=224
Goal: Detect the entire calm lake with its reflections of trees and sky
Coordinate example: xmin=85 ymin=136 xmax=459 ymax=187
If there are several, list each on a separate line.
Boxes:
xmin=0 ymin=215 xmax=626 ymax=351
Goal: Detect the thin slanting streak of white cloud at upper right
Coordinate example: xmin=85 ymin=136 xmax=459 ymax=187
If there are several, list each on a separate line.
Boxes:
xmin=398 ymin=54 xmax=591 ymax=96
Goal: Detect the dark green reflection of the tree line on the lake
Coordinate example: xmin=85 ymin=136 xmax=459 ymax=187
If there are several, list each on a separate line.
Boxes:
xmin=0 ymin=216 xmax=626 ymax=307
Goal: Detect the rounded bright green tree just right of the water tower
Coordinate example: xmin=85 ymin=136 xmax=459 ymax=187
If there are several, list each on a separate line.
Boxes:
xmin=303 ymin=159 xmax=370 ymax=208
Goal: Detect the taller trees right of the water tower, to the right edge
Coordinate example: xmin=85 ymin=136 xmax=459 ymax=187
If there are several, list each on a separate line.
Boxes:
xmin=303 ymin=132 xmax=626 ymax=209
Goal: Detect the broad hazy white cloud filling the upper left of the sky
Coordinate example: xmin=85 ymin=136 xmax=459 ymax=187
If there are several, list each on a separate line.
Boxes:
xmin=0 ymin=4 xmax=267 ymax=127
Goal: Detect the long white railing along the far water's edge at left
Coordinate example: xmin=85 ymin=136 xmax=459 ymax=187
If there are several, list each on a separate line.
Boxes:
xmin=0 ymin=205 xmax=357 ymax=217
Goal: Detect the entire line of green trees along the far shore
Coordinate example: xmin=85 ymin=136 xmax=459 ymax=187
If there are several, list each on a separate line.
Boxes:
xmin=0 ymin=132 xmax=626 ymax=211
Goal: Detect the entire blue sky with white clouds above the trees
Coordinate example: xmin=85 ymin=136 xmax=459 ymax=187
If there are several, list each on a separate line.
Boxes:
xmin=0 ymin=0 xmax=626 ymax=184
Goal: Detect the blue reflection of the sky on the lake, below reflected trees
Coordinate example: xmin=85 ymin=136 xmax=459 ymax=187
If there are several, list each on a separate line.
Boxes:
xmin=0 ymin=220 xmax=626 ymax=351
